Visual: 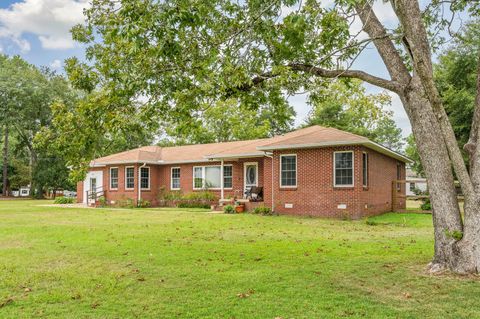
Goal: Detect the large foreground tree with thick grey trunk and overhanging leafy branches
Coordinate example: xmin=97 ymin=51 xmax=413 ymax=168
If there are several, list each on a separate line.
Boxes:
xmin=59 ymin=0 xmax=480 ymax=273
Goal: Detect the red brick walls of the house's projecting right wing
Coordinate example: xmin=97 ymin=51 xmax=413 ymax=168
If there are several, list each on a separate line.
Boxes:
xmin=264 ymin=146 xmax=405 ymax=218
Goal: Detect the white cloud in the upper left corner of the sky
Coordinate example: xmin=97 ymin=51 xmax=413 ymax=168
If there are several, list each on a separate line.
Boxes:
xmin=0 ymin=0 xmax=88 ymax=52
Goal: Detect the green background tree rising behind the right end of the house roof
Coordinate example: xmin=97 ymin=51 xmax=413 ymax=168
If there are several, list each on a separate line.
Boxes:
xmin=306 ymin=80 xmax=403 ymax=151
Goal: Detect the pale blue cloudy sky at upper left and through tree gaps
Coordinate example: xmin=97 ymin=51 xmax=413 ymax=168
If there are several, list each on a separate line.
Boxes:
xmin=0 ymin=0 xmax=464 ymax=136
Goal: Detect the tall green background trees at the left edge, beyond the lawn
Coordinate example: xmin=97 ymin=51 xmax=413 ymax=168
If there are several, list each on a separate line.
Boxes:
xmin=0 ymin=55 xmax=78 ymax=197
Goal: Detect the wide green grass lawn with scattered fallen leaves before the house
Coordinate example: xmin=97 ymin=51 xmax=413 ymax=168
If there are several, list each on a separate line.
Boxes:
xmin=0 ymin=201 xmax=480 ymax=319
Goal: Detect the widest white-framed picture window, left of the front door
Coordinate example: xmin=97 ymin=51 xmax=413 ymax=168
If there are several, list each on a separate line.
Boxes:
xmin=193 ymin=165 xmax=233 ymax=189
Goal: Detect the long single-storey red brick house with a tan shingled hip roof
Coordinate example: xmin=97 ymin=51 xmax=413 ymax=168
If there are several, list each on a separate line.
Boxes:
xmin=77 ymin=126 xmax=410 ymax=218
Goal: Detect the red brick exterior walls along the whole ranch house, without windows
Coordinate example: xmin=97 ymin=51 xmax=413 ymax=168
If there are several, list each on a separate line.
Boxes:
xmin=77 ymin=146 xmax=405 ymax=218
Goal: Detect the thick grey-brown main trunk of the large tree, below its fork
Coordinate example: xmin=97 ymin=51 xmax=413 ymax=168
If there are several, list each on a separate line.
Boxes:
xmin=400 ymin=76 xmax=480 ymax=273
